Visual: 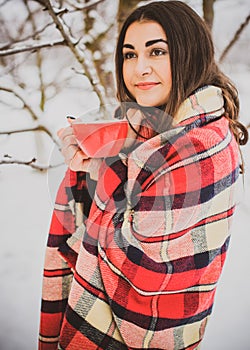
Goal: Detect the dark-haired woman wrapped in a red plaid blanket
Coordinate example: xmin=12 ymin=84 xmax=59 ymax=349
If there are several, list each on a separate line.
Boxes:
xmin=39 ymin=1 xmax=248 ymax=350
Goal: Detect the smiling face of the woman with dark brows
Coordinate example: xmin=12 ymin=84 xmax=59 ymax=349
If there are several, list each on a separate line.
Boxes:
xmin=122 ymin=21 xmax=172 ymax=107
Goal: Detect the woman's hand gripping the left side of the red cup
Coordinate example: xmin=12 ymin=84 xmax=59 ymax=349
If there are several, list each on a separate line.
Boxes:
xmin=57 ymin=120 xmax=102 ymax=180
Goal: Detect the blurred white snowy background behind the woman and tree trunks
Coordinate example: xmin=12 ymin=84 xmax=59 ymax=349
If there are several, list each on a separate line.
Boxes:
xmin=0 ymin=0 xmax=250 ymax=350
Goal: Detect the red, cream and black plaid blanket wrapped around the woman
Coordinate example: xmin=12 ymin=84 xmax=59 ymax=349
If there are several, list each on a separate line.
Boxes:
xmin=39 ymin=86 xmax=239 ymax=350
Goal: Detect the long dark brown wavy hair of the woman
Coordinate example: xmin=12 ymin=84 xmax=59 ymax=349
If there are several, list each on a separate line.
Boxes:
xmin=115 ymin=1 xmax=248 ymax=149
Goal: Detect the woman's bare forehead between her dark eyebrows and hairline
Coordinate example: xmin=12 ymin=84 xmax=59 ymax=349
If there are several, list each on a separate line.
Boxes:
xmin=124 ymin=21 xmax=167 ymax=44
